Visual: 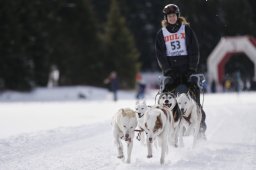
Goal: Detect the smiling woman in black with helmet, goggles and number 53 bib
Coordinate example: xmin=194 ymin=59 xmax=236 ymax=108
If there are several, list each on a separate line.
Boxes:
xmin=155 ymin=4 xmax=206 ymax=138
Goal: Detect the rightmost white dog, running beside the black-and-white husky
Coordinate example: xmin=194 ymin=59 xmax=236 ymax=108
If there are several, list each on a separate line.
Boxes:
xmin=176 ymin=93 xmax=202 ymax=147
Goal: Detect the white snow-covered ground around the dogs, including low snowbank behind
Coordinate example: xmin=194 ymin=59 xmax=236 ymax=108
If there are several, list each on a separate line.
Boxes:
xmin=0 ymin=87 xmax=256 ymax=170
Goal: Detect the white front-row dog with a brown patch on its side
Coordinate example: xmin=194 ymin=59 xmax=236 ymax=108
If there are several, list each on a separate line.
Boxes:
xmin=144 ymin=106 xmax=170 ymax=164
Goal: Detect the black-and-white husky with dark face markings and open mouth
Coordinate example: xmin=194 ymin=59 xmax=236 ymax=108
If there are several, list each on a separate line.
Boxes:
xmin=158 ymin=93 xmax=181 ymax=147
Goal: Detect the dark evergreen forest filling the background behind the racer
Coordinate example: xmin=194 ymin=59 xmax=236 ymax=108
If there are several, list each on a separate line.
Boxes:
xmin=0 ymin=0 xmax=256 ymax=91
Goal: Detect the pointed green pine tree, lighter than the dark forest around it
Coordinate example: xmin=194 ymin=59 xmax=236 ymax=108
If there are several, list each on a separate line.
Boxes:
xmin=104 ymin=0 xmax=139 ymax=88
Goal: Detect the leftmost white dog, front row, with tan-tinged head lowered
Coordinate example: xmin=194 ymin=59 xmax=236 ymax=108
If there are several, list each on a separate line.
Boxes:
xmin=112 ymin=108 xmax=137 ymax=163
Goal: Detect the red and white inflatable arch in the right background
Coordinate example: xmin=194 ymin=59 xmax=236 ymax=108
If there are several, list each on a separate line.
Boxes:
xmin=207 ymin=36 xmax=256 ymax=84
